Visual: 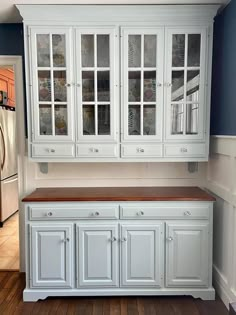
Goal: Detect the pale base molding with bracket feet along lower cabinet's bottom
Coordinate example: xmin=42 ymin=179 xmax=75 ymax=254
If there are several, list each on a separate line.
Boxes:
xmin=23 ymin=288 xmax=215 ymax=302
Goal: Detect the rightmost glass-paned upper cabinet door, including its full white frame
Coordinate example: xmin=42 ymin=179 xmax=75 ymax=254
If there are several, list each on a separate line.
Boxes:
xmin=165 ymin=27 xmax=207 ymax=141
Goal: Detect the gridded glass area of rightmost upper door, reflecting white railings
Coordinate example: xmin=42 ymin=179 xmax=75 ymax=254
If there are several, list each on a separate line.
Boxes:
xmin=167 ymin=30 xmax=205 ymax=139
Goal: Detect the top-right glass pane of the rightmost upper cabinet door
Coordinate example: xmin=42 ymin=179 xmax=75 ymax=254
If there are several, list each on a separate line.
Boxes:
xmin=188 ymin=34 xmax=201 ymax=67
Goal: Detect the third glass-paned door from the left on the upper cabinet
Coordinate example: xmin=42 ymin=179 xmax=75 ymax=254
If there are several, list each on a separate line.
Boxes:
xmin=121 ymin=27 xmax=164 ymax=142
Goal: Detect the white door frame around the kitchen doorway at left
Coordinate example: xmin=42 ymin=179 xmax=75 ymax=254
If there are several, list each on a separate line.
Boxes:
xmin=0 ymin=56 xmax=25 ymax=271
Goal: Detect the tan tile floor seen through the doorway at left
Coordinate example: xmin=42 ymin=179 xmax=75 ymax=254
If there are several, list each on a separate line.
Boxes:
xmin=0 ymin=212 xmax=19 ymax=271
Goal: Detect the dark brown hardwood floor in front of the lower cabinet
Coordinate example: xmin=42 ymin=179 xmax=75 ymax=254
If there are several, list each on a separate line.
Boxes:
xmin=0 ymin=271 xmax=228 ymax=315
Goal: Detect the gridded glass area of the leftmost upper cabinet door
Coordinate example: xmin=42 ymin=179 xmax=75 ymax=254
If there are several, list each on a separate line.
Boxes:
xmin=31 ymin=29 xmax=72 ymax=140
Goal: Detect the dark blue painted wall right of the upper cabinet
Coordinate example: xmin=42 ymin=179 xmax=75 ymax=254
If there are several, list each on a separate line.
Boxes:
xmin=211 ymin=0 xmax=236 ymax=135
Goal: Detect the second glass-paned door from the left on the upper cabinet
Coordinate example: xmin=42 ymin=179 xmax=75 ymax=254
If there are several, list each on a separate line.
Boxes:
xmin=76 ymin=28 xmax=119 ymax=142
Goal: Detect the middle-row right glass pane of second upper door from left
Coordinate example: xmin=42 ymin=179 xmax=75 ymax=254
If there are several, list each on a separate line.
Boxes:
xmin=97 ymin=71 xmax=110 ymax=102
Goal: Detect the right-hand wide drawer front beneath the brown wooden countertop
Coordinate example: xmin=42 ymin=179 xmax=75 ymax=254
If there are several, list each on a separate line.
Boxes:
xmin=121 ymin=205 xmax=209 ymax=220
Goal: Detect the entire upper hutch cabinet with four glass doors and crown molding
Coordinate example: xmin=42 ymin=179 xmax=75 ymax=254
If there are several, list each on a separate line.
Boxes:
xmin=17 ymin=5 xmax=218 ymax=162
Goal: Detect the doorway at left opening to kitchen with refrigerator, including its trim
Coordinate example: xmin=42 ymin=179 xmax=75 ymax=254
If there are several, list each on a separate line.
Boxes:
xmin=0 ymin=56 xmax=25 ymax=271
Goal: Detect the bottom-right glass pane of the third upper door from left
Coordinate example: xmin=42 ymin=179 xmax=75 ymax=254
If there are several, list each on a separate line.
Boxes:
xmin=143 ymin=105 xmax=156 ymax=135
